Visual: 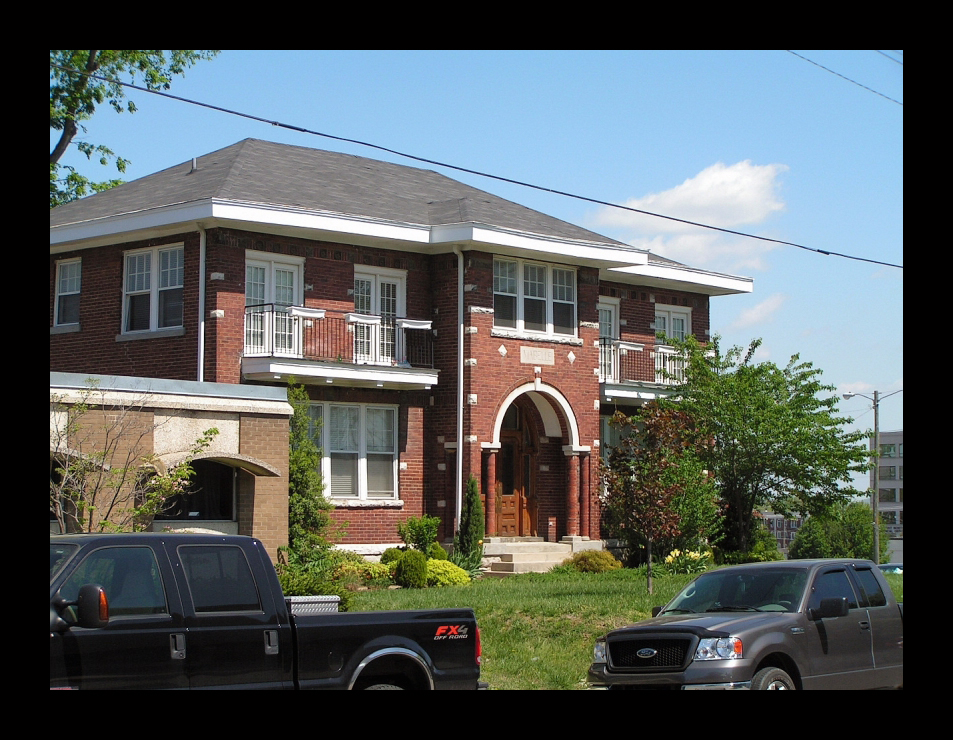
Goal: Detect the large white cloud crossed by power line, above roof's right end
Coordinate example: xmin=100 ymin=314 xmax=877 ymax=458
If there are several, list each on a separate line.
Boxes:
xmin=594 ymin=160 xmax=788 ymax=272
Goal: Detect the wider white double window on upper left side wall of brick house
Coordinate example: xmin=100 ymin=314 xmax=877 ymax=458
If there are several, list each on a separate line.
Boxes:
xmin=123 ymin=245 xmax=185 ymax=333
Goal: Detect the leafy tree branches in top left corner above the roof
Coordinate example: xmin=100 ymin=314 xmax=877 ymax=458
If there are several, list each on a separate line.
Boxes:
xmin=50 ymin=49 xmax=218 ymax=208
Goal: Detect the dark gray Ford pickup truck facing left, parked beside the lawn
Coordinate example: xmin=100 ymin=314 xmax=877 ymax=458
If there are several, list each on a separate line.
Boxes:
xmin=588 ymin=560 xmax=903 ymax=690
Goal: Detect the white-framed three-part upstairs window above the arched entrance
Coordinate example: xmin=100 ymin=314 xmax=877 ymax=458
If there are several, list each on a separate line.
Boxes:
xmin=493 ymin=259 xmax=576 ymax=336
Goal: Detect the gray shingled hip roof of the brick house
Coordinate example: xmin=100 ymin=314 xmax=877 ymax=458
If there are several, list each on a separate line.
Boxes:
xmin=50 ymin=139 xmax=640 ymax=248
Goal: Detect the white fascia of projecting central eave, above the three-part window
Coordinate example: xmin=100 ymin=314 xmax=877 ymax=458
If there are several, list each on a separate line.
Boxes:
xmin=430 ymin=223 xmax=648 ymax=268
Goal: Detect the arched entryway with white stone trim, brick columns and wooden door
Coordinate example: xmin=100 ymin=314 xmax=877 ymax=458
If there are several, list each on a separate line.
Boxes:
xmin=482 ymin=382 xmax=589 ymax=541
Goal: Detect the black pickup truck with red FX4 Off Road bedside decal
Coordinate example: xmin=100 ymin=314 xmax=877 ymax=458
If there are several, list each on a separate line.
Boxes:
xmin=50 ymin=533 xmax=483 ymax=689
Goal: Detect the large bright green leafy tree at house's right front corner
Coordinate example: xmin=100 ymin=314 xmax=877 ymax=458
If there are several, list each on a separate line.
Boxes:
xmin=662 ymin=337 xmax=868 ymax=552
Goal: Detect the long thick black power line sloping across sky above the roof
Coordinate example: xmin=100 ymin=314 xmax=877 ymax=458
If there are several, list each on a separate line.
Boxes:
xmin=50 ymin=62 xmax=903 ymax=270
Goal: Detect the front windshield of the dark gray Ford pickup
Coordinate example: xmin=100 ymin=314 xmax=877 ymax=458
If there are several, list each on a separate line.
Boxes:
xmin=662 ymin=569 xmax=807 ymax=614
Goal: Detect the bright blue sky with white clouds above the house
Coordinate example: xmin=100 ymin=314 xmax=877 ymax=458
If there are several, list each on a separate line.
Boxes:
xmin=52 ymin=50 xmax=904 ymax=486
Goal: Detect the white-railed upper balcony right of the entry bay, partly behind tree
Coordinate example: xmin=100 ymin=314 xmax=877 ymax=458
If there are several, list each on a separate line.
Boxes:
xmin=599 ymin=337 xmax=685 ymax=401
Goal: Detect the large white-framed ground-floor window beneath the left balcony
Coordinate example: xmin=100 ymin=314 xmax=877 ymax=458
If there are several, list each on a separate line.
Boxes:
xmin=310 ymin=403 xmax=397 ymax=500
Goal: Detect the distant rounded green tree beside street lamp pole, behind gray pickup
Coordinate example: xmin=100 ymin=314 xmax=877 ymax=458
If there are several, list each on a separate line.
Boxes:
xmin=788 ymin=501 xmax=890 ymax=563
